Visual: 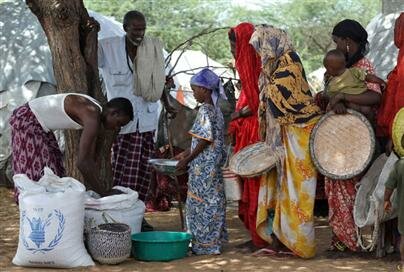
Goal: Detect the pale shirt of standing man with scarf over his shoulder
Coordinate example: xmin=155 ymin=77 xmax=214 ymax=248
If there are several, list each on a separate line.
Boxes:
xmin=98 ymin=36 xmax=159 ymax=134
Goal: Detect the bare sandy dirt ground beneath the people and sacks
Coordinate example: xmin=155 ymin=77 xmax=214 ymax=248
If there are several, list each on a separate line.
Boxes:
xmin=0 ymin=187 xmax=399 ymax=272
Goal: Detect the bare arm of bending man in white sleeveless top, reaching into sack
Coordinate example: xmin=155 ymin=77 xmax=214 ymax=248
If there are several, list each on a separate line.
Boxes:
xmin=65 ymin=96 xmax=105 ymax=195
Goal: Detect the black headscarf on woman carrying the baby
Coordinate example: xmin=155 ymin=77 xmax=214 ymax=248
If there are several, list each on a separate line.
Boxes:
xmin=332 ymin=19 xmax=369 ymax=68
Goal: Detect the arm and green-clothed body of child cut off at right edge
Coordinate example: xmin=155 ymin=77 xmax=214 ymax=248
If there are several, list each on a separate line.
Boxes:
xmin=384 ymin=135 xmax=404 ymax=272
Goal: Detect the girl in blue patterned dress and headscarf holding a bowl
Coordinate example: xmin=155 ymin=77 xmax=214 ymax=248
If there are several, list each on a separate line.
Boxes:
xmin=176 ymin=68 xmax=227 ymax=255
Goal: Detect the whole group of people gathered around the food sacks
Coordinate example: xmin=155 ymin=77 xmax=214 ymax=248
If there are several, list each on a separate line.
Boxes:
xmin=11 ymin=7 xmax=404 ymax=270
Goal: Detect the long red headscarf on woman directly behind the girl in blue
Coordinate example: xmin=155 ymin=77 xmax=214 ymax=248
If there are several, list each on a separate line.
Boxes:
xmin=230 ymin=23 xmax=261 ymax=113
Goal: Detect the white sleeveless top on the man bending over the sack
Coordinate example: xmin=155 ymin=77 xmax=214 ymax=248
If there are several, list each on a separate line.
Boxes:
xmin=28 ymin=93 xmax=102 ymax=132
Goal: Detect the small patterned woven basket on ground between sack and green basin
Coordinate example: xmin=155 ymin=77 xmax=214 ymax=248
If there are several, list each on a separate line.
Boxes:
xmin=87 ymin=223 xmax=132 ymax=264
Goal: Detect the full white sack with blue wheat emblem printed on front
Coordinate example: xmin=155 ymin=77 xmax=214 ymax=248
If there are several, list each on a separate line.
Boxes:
xmin=13 ymin=167 xmax=94 ymax=268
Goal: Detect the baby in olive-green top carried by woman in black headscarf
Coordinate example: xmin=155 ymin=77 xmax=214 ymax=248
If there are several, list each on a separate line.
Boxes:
xmin=323 ymin=49 xmax=386 ymax=116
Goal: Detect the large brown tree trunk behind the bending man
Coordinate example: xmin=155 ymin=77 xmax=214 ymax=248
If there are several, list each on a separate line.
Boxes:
xmin=26 ymin=0 xmax=113 ymax=189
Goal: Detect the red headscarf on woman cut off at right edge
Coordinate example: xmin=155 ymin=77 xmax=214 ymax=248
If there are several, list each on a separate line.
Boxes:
xmin=377 ymin=13 xmax=404 ymax=137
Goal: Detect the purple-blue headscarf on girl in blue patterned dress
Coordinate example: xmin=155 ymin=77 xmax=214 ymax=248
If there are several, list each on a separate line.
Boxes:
xmin=191 ymin=68 xmax=227 ymax=107
